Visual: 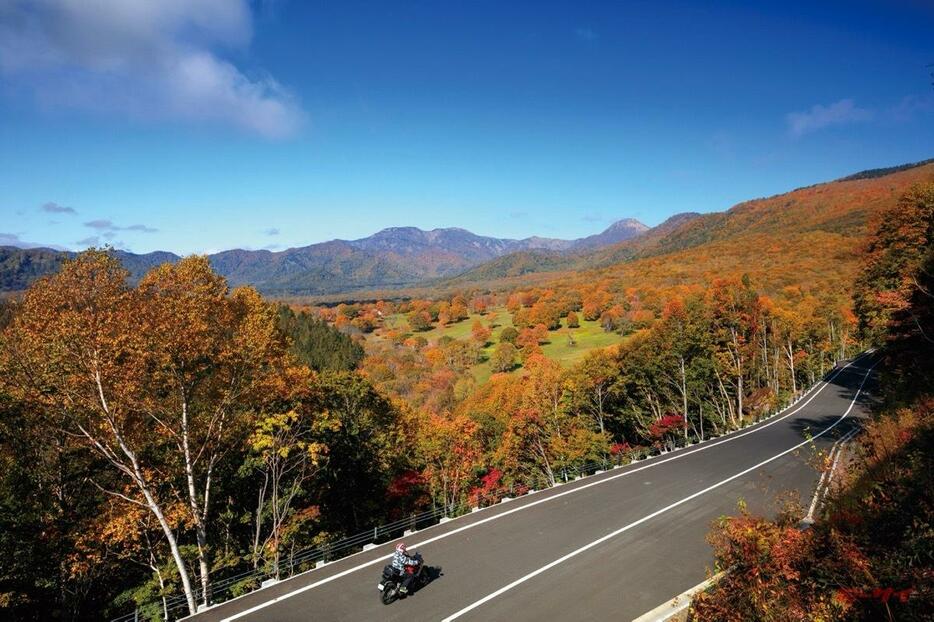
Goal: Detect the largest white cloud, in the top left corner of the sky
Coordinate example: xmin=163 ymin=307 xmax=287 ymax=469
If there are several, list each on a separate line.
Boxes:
xmin=0 ymin=0 xmax=303 ymax=138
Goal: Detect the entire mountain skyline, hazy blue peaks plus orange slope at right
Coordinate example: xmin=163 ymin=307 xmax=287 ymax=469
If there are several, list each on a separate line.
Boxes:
xmin=0 ymin=160 xmax=934 ymax=300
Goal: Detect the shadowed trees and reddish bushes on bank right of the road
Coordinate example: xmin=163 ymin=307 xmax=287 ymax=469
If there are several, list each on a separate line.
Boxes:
xmin=693 ymin=184 xmax=934 ymax=622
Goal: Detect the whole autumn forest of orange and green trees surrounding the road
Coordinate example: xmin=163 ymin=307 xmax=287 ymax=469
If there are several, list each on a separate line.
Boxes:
xmin=0 ymin=164 xmax=934 ymax=620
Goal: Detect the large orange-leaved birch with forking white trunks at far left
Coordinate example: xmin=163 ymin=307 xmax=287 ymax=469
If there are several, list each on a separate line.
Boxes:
xmin=3 ymin=250 xmax=296 ymax=613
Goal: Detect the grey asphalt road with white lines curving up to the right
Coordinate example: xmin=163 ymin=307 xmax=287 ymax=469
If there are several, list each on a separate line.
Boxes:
xmin=189 ymin=356 xmax=873 ymax=622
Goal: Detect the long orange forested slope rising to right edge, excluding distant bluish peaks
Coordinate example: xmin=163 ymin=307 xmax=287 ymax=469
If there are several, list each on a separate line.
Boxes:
xmin=436 ymin=161 xmax=934 ymax=298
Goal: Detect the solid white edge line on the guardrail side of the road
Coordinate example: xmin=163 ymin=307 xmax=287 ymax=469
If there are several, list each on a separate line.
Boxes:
xmin=218 ymin=355 xmax=875 ymax=622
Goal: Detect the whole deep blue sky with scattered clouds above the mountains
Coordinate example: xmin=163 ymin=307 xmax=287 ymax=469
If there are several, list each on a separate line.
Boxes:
xmin=0 ymin=0 xmax=934 ymax=253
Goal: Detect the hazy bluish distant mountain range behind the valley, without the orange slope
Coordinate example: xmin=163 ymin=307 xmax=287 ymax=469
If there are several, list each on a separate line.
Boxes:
xmin=0 ymin=218 xmax=649 ymax=295
